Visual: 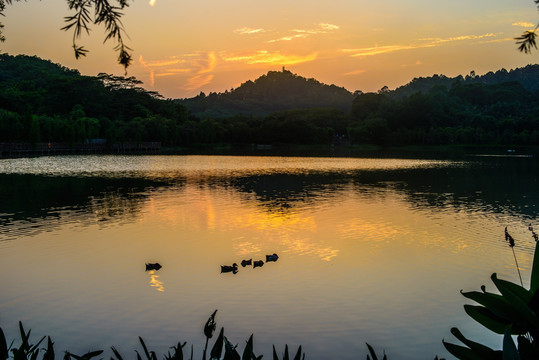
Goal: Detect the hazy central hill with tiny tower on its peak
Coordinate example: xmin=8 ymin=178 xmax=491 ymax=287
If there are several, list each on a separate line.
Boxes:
xmin=176 ymin=68 xmax=354 ymax=118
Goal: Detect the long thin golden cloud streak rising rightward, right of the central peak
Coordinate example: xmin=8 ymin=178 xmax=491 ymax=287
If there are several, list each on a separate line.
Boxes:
xmin=341 ymin=33 xmax=499 ymax=57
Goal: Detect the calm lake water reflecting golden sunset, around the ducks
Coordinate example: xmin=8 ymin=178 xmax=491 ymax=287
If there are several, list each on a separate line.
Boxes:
xmin=0 ymin=156 xmax=539 ymax=360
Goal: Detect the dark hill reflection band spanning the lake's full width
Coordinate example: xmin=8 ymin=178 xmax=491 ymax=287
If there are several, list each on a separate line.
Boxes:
xmin=0 ymin=159 xmax=539 ymax=238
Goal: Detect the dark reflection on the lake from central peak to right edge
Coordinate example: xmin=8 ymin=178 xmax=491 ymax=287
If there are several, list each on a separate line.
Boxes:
xmin=228 ymin=159 xmax=539 ymax=217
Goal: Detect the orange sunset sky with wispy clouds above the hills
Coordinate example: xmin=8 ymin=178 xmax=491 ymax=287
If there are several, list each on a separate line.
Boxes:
xmin=0 ymin=0 xmax=539 ymax=98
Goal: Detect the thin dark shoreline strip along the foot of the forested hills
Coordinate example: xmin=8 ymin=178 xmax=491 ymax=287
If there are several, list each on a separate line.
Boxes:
xmin=0 ymin=142 xmax=539 ymax=159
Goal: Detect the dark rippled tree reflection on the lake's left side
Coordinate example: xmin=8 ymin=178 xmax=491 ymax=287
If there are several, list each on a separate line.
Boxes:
xmin=0 ymin=175 xmax=168 ymax=238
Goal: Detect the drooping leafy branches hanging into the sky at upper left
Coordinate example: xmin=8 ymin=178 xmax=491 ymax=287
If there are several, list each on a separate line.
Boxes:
xmin=0 ymin=0 xmax=133 ymax=69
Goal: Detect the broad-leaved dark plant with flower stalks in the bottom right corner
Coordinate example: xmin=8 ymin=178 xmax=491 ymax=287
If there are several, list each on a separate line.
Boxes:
xmin=443 ymin=225 xmax=539 ymax=360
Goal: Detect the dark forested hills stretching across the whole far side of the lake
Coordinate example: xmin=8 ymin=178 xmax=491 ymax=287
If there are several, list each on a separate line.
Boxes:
xmin=0 ymin=54 xmax=539 ymax=147
